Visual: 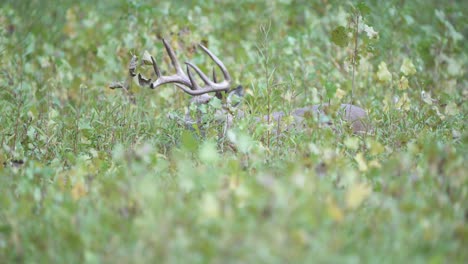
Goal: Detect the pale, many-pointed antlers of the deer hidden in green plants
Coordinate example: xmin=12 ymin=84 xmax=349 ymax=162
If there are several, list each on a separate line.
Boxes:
xmin=138 ymin=39 xmax=231 ymax=96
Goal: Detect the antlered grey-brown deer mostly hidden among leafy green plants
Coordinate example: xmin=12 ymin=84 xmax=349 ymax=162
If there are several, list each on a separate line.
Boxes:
xmin=110 ymin=39 xmax=369 ymax=134
